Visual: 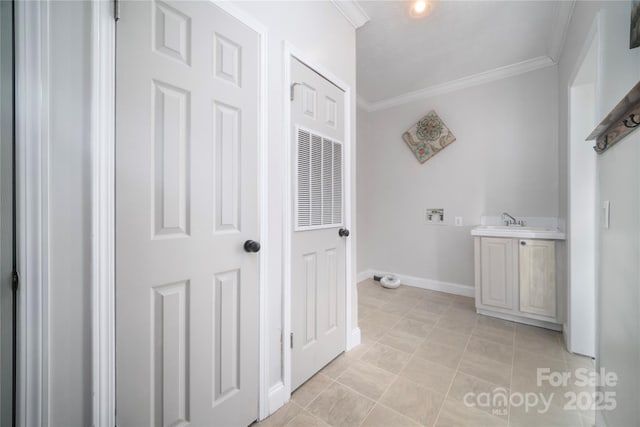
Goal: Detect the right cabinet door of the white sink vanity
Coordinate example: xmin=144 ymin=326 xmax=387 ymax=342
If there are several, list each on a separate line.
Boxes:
xmin=519 ymin=239 xmax=556 ymax=318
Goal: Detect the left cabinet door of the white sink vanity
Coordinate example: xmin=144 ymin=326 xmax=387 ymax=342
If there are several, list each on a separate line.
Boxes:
xmin=480 ymin=237 xmax=518 ymax=310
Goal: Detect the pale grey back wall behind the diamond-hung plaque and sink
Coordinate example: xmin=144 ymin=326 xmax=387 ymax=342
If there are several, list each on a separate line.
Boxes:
xmin=358 ymin=67 xmax=558 ymax=286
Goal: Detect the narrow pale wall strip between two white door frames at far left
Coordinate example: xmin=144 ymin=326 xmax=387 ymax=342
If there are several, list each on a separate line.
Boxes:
xmin=48 ymin=1 xmax=92 ymax=426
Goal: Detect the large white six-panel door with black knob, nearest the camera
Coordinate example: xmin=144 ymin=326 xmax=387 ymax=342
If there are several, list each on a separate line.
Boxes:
xmin=116 ymin=1 xmax=260 ymax=427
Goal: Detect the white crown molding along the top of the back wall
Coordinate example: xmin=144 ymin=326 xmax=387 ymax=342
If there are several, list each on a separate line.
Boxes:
xmin=358 ymin=56 xmax=556 ymax=112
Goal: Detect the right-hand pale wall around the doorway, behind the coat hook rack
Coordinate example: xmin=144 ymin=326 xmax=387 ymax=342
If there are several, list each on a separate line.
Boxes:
xmin=559 ymin=1 xmax=640 ymax=426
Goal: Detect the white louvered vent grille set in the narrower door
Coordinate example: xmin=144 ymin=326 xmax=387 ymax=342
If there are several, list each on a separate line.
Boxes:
xmin=295 ymin=128 xmax=342 ymax=230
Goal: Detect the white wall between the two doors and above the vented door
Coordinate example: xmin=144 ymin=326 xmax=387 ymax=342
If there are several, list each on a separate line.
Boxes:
xmin=231 ymin=1 xmax=357 ymax=402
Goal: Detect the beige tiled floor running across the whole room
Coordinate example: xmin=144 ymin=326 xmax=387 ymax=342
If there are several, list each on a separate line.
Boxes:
xmin=257 ymin=280 xmax=594 ymax=427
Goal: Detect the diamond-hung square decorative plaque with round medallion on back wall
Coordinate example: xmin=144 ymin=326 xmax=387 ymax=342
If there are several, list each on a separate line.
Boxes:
xmin=402 ymin=111 xmax=456 ymax=163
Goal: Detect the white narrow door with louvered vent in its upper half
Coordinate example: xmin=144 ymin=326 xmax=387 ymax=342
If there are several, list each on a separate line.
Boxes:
xmin=291 ymin=59 xmax=348 ymax=389
